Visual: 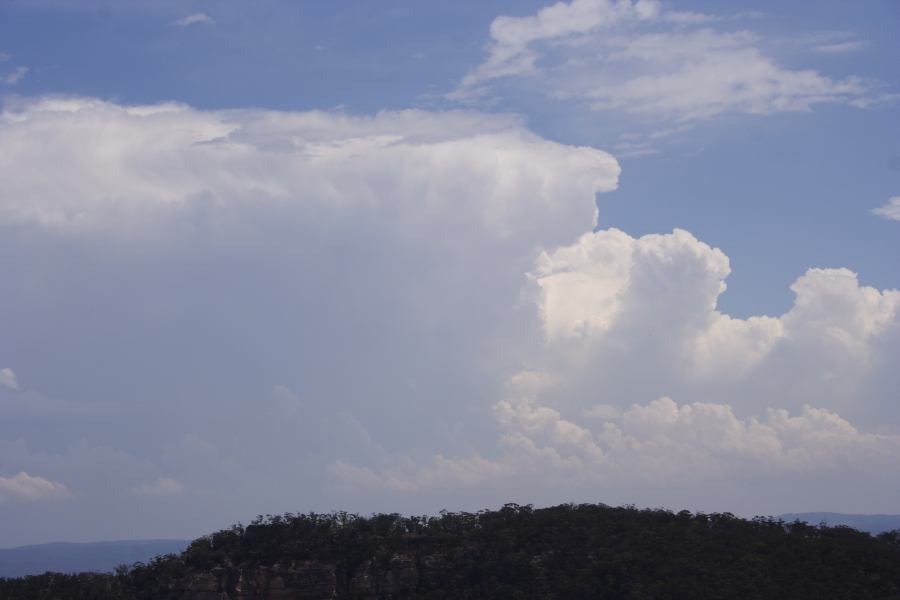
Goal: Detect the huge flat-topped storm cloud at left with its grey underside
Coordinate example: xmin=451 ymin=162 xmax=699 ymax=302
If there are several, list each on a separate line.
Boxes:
xmin=0 ymin=97 xmax=619 ymax=522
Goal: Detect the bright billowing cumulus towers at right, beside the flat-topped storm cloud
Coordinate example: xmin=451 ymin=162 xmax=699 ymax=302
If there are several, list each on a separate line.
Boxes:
xmin=333 ymin=223 xmax=900 ymax=511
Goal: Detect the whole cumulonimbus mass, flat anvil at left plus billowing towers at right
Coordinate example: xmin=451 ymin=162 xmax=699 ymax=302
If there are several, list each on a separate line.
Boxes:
xmin=0 ymin=95 xmax=900 ymax=524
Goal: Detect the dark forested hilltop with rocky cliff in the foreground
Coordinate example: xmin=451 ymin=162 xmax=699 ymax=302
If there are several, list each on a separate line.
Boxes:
xmin=0 ymin=504 xmax=900 ymax=600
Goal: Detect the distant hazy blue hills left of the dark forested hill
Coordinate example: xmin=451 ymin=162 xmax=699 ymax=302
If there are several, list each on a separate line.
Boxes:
xmin=0 ymin=540 xmax=191 ymax=577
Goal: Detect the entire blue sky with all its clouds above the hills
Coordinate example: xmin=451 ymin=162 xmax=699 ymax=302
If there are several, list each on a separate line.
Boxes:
xmin=0 ymin=0 xmax=900 ymax=546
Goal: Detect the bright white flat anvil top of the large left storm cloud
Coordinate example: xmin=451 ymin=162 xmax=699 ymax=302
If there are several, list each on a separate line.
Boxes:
xmin=0 ymin=98 xmax=619 ymax=238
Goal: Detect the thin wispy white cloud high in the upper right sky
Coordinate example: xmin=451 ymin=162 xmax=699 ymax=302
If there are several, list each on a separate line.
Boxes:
xmin=451 ymin=0 xmax=873 ymax=123
